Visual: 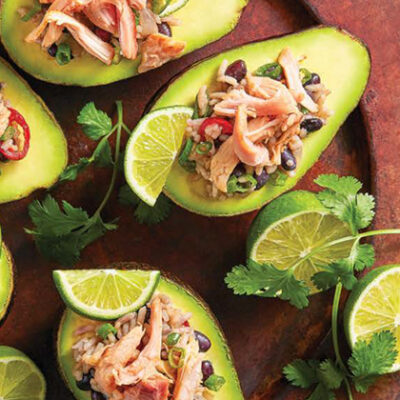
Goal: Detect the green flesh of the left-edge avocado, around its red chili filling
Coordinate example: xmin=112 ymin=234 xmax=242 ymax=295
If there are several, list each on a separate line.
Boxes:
xmin=0 ymin=59 xmax=68 ymax=203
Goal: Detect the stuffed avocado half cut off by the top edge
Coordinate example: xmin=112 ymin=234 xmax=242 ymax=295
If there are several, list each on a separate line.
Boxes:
xmin=1 ymin=0 xmax=247 ymax=86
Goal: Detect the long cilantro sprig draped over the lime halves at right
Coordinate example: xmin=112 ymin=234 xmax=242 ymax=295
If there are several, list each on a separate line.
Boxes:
xmin=225 ymin=174 xmax=400 ymax=400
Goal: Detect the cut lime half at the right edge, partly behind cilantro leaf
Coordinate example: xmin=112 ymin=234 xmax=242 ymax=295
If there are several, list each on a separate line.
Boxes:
xmin=344 ymin=265 xmax=400 ymax=372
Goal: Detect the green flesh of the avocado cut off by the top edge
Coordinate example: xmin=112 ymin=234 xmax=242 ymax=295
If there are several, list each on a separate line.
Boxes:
xmin=0 ymin=0 xmax=248 ymax=86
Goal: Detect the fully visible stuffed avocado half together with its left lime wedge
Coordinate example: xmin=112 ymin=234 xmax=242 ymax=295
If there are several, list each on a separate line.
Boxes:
xmin=125 ymin=27 xmax=370 ymax=216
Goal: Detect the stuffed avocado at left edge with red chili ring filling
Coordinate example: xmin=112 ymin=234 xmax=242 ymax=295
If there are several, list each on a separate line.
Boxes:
xmin=0 ymin=59 xmax=68 ymax=203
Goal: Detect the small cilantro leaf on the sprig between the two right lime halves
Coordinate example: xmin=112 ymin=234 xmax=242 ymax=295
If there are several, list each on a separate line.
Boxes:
xmin=311 ymin=258 xmax=357 ymax=290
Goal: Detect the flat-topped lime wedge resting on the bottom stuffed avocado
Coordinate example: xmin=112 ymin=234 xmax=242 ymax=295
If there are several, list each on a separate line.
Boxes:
xmin=53 ymin=269 xmax=160 ymax=320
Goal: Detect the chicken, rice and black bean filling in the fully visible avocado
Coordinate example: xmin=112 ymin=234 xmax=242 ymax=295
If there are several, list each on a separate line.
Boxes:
xmin=179 ymin=49 xmax=331 ymax=198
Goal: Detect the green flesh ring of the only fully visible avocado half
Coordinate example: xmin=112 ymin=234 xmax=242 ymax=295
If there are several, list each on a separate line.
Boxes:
xmin=153 ymin=27 xmax=370 ymax=216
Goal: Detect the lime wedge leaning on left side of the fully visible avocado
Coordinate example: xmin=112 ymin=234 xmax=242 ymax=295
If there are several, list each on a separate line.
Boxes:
xmin=125 ymin=106 xmax=193 ymax=206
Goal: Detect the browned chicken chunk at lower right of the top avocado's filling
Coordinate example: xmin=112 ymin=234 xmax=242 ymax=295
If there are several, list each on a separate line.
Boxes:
xmin=138 ymin=33 xmax=186 ymax=73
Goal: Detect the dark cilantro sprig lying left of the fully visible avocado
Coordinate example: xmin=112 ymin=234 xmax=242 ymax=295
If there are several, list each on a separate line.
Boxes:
xmin=25 ymin=101 xmax=127 ymax=265
